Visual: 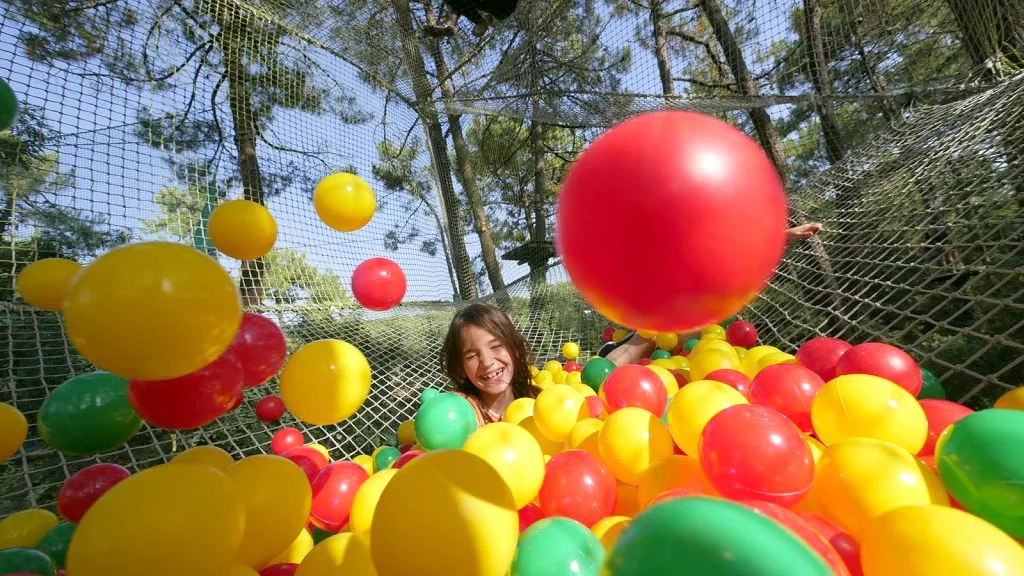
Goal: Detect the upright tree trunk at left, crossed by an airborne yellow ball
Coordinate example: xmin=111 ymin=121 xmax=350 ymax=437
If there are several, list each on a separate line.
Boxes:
xmin=215 ymin=3 xmax=265 ymax=308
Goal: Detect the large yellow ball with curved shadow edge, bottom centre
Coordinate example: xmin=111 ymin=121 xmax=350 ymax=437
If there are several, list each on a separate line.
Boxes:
xmin=370 ymin=450 xmax=519 ymax=576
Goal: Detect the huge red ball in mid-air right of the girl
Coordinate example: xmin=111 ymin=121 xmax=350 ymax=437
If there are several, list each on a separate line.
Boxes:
xmin=555 ymin=111 xmax=786 ymax=332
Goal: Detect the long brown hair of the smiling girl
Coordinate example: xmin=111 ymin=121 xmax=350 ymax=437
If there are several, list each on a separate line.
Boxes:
xmin=440 ymin=302 xmax=541 ymax=418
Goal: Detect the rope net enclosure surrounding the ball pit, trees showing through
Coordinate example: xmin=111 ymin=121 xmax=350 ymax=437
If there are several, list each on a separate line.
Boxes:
xmin=0 ymin=0 xmax=1024 ymax=517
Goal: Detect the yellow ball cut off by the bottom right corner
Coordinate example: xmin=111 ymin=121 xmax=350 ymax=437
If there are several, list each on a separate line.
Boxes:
xmin=860 ymin=505 xmax=1024 ymax=576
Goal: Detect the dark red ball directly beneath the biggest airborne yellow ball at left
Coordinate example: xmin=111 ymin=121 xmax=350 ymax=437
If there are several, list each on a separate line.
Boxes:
xmin=128 ymin=353 xmax=242 ymax=430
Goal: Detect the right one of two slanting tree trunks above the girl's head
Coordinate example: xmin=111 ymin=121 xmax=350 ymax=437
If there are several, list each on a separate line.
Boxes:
xmin=427 ymin=25 xmax=509 ymax=304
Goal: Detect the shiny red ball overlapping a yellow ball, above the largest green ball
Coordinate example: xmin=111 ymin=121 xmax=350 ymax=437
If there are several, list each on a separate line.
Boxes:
xmin=698 ymin=404 xmax=814 ymax=506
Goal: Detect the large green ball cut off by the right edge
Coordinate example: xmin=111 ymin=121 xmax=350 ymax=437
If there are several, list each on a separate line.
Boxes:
xmin=935 ymin=408 xmax=1024 ymax=538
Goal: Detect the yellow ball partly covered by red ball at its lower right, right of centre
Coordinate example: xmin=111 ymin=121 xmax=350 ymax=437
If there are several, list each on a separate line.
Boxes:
xmin=669 ymin=380 xmax=750 ymax=458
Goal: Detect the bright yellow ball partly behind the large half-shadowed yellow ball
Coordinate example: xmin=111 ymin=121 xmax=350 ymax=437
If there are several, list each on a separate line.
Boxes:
xmin=462 ymin=416 xmax=544 ymax=509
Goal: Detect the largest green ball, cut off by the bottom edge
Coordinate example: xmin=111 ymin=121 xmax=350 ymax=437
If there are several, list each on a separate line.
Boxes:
xmin=606 ymin=497 xmax=833 ymax=576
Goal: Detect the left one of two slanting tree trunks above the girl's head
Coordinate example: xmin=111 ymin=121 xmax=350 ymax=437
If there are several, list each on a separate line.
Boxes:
xmin=391 ymin=0 xmax=477 ymax=300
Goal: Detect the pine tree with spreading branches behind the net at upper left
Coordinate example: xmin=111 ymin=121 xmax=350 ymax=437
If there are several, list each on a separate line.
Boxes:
xmin=12 ymin=0 xmax=367 ymax=306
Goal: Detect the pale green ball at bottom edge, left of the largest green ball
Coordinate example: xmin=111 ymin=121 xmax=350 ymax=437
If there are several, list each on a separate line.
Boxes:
xmin=511 ymin=518 xmax=604 ymax=576
